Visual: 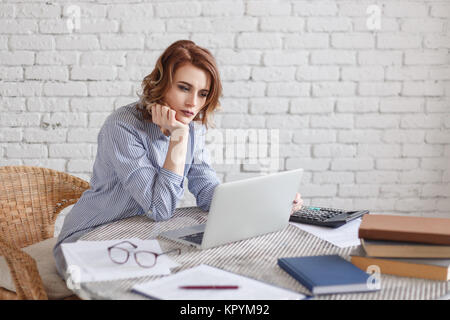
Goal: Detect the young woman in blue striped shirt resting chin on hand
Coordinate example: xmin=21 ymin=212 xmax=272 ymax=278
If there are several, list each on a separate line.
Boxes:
xmin=53 ymin=40 xmax=302 ymax=278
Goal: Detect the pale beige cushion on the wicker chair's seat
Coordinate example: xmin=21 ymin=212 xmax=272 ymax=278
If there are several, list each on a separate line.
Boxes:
xmin=0 ymin=238 xmax=74 ymax=299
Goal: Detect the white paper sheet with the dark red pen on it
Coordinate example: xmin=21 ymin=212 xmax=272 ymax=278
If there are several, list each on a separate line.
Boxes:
xmin=133 ymin=264 xmax=306 ymax=300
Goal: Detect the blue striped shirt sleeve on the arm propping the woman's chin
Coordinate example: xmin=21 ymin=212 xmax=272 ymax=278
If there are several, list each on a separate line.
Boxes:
xmin=103 ymin=122 xmax=184 ymax=221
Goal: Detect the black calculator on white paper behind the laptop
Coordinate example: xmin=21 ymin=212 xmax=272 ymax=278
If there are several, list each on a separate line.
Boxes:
xmin=289 ymin=206 xmax=369 ymax=228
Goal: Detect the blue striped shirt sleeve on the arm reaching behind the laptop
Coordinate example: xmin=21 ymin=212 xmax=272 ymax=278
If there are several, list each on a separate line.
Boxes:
xmin=187 ymin=127 xmax=220 ymax=211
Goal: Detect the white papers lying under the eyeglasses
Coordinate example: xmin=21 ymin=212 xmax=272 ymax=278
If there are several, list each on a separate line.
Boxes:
xmin=61 ymin=238 xmax=179 ymax=283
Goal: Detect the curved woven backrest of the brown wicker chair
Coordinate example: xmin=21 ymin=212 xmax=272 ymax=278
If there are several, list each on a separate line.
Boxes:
xmin=0 ymin=166 xmax=89 ymax=248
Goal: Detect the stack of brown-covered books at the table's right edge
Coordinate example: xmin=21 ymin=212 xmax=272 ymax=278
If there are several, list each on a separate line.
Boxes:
xmin=350 ymin=214 xmax=450 ymax=281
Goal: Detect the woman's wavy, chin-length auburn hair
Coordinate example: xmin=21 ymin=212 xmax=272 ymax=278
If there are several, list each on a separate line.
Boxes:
xmin=137 ymin=40 xmax=222 ymax=128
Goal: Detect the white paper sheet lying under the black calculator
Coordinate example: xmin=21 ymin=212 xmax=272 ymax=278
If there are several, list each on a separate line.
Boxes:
xmin=290 ymin=218 xmax=361 ymax=248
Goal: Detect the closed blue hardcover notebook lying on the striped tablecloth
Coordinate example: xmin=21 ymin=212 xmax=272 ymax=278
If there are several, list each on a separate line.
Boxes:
xmin=278 ymin=255 xmax=379 ymax=294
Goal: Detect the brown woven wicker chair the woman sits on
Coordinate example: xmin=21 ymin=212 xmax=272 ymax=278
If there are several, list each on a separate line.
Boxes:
xmin=0 ymin=166 xmax=89 ymax=300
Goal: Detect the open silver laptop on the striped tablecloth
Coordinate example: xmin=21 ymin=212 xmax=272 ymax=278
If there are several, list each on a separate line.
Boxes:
xmin=160 ymin=169 xmax=303 ymax=249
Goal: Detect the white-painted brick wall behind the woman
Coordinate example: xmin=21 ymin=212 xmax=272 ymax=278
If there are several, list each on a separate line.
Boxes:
xmin=0 ymin=0 xmax=450 ymax=235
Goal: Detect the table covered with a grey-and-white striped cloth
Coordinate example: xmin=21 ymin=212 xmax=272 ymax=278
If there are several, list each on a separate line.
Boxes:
xmin=70 ymin=207 xmax=450 ymax=300
